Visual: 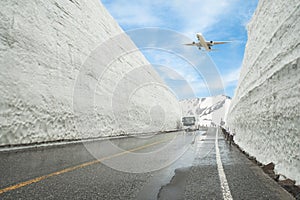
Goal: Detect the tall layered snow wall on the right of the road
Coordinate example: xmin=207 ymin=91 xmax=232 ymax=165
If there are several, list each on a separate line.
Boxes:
xmin=227 ymin=0 xmax=300 ymax=184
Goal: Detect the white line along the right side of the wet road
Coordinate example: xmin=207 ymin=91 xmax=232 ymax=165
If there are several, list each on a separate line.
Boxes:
xmin=215 ymin=128 xmax=232 ymax=200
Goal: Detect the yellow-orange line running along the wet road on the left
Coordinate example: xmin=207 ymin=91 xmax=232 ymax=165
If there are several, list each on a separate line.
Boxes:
xmin=0 ymin=138 xmax=172 ymax=194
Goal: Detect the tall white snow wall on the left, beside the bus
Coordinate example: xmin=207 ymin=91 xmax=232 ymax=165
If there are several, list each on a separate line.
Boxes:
xmin=0 ymin=0 xmax=181 ymax=146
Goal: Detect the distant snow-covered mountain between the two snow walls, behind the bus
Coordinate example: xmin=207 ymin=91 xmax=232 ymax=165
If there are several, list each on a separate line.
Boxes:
xmin=180 ymin=95 xmax=231 ymax=126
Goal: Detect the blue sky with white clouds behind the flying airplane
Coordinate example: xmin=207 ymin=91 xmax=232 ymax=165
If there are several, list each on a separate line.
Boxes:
xmin=101 ymin=0 xmax=258 ymax=99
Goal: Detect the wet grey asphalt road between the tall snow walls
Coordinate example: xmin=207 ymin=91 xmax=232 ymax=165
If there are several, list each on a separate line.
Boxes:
xmin=0 ymin=128 xmax=293 ymax=200
